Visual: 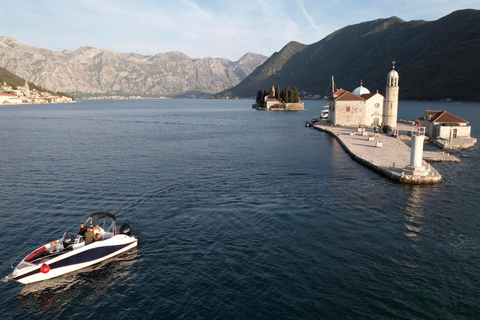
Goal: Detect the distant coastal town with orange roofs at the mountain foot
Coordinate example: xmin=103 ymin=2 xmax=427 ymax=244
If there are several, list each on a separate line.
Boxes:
xmin=0 ymin=81 xmax=75 ymax=105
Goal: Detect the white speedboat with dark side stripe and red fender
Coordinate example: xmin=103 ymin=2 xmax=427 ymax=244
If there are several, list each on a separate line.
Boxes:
xmin=4 ymin=212 xmax=137 ymax=284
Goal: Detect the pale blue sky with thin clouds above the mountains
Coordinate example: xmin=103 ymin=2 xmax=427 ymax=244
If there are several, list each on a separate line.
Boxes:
xmin=0 ymin=0 xmax=480 ymax=61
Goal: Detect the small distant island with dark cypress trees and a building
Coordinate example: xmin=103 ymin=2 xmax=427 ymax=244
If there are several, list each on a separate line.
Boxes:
xmin=252 ymin=85 xmax=305 ymax=111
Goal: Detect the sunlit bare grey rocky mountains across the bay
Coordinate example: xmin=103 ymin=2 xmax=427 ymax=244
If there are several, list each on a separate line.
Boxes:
xmin=0 ymin=37 xmax=267 ymax=97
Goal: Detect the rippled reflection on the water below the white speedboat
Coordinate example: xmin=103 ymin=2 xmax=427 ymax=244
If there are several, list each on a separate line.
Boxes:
xmin=18 ymin=248 xmax=139 ymax=314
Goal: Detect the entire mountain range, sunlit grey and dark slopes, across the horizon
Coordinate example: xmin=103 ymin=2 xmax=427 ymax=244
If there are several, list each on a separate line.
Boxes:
xmin=0 ymin=9 xmax=480 ymax=100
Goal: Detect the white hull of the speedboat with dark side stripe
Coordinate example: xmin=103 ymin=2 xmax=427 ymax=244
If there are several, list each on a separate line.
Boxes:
xmin=10 ymin=234 xmax=137 ymax=284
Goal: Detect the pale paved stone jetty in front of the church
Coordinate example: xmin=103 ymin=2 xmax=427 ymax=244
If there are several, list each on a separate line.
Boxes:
xmin=313 ymin=123 xmax=442 ymax=184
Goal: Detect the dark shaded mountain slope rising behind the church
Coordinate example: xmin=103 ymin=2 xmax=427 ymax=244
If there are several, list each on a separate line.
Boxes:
xmin=218 ymin=10 xmax=480 ymax=100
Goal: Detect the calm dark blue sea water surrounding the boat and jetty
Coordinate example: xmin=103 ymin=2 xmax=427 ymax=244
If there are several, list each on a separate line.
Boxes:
xmin=0 ymin=100 xmax=480 ymax=319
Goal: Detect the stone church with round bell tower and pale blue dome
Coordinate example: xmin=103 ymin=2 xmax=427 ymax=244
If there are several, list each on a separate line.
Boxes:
xmin=328 ymin=61 xmax=399 ymax=131
